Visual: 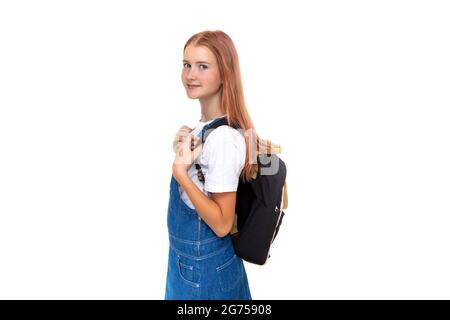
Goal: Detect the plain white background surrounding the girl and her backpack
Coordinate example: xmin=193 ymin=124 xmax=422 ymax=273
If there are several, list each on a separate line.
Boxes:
xmin=0 ymin=0 xmax=450 ymax=299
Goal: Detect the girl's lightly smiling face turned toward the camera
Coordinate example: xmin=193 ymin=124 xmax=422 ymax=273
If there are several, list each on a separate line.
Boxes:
xmin=181 ymin=45 xmax=222 ymax=99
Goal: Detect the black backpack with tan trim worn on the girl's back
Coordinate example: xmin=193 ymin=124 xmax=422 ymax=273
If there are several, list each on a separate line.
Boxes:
xmin=195 ymin=117 xmax=287 ymax=265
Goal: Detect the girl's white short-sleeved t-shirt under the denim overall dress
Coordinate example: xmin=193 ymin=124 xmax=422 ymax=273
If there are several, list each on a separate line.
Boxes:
xmin=179 ymin=118 xmax=246 ymax=209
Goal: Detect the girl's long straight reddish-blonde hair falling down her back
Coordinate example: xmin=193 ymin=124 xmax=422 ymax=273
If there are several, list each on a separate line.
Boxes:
xmin=183 ymin=30 xmax=281 ymax=181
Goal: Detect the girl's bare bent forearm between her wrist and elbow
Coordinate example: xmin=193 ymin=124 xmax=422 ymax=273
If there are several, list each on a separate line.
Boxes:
xmin=174 ymin=169 xmax=228 ymax=237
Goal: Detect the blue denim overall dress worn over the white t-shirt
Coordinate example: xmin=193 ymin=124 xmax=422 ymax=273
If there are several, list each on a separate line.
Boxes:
xmin=165 ymin=117 xmax=252 ymax=300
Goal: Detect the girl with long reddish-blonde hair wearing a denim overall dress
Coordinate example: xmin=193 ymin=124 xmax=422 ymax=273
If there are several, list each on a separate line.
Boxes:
xmin=165 ymin=31 xmax=278 ymax=300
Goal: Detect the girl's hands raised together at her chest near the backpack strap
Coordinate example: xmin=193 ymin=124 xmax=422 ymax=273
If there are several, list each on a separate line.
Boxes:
xmin=172 ymin=126 xmax=202 ymax=176
